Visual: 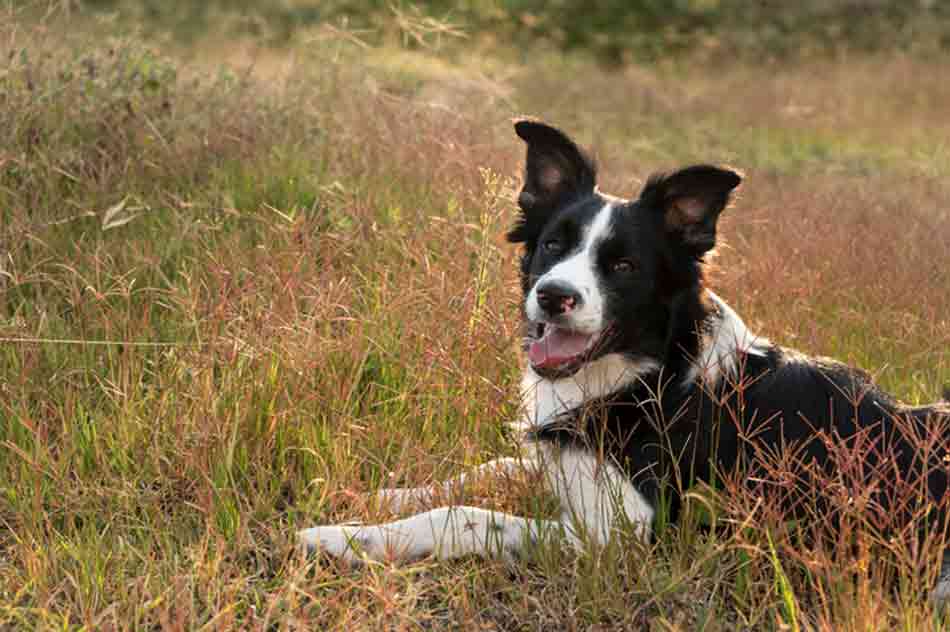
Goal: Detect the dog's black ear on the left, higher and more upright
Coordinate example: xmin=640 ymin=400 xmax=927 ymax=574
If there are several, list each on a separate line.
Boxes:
xmin=508 ymin=118 xmax=597 ymax=243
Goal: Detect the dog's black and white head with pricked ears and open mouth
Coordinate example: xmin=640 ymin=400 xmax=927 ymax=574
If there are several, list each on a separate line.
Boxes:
xmin=508 ymin=119 xmax=741 ymax=378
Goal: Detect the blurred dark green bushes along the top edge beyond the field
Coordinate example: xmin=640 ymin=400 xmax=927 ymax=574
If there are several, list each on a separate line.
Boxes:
xmin=66 ymin=0 xmax=950 ymax=64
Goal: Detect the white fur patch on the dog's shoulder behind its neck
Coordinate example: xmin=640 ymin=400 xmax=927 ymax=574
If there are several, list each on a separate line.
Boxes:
xmin=685 ymin=290 xmax=770 ymax=387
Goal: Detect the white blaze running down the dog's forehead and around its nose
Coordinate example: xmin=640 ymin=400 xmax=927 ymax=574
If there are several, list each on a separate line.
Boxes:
xmin=525 ymin=200 xmax=615 ymax=334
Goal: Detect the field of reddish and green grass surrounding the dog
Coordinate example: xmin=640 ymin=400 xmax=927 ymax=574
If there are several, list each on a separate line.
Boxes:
xmin=0 ymin=2 xmax=950 ymax=631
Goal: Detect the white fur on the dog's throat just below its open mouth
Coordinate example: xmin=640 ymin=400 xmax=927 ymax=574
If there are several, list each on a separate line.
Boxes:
xmin=521 ymin=353 xmax=659 ymax=427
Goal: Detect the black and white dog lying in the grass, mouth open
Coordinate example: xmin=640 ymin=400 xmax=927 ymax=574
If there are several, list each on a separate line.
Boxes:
xmin=298 ymin=119 xmax=950 ymax=596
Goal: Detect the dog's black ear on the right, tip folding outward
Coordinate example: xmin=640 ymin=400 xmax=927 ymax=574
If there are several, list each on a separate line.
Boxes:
xmin=640 ymin=165 xmax=742 ymax=255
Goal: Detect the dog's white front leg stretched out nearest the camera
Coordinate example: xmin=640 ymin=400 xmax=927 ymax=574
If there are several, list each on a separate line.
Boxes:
xmin=297 ymin=506 xmax=560 ymax=563
